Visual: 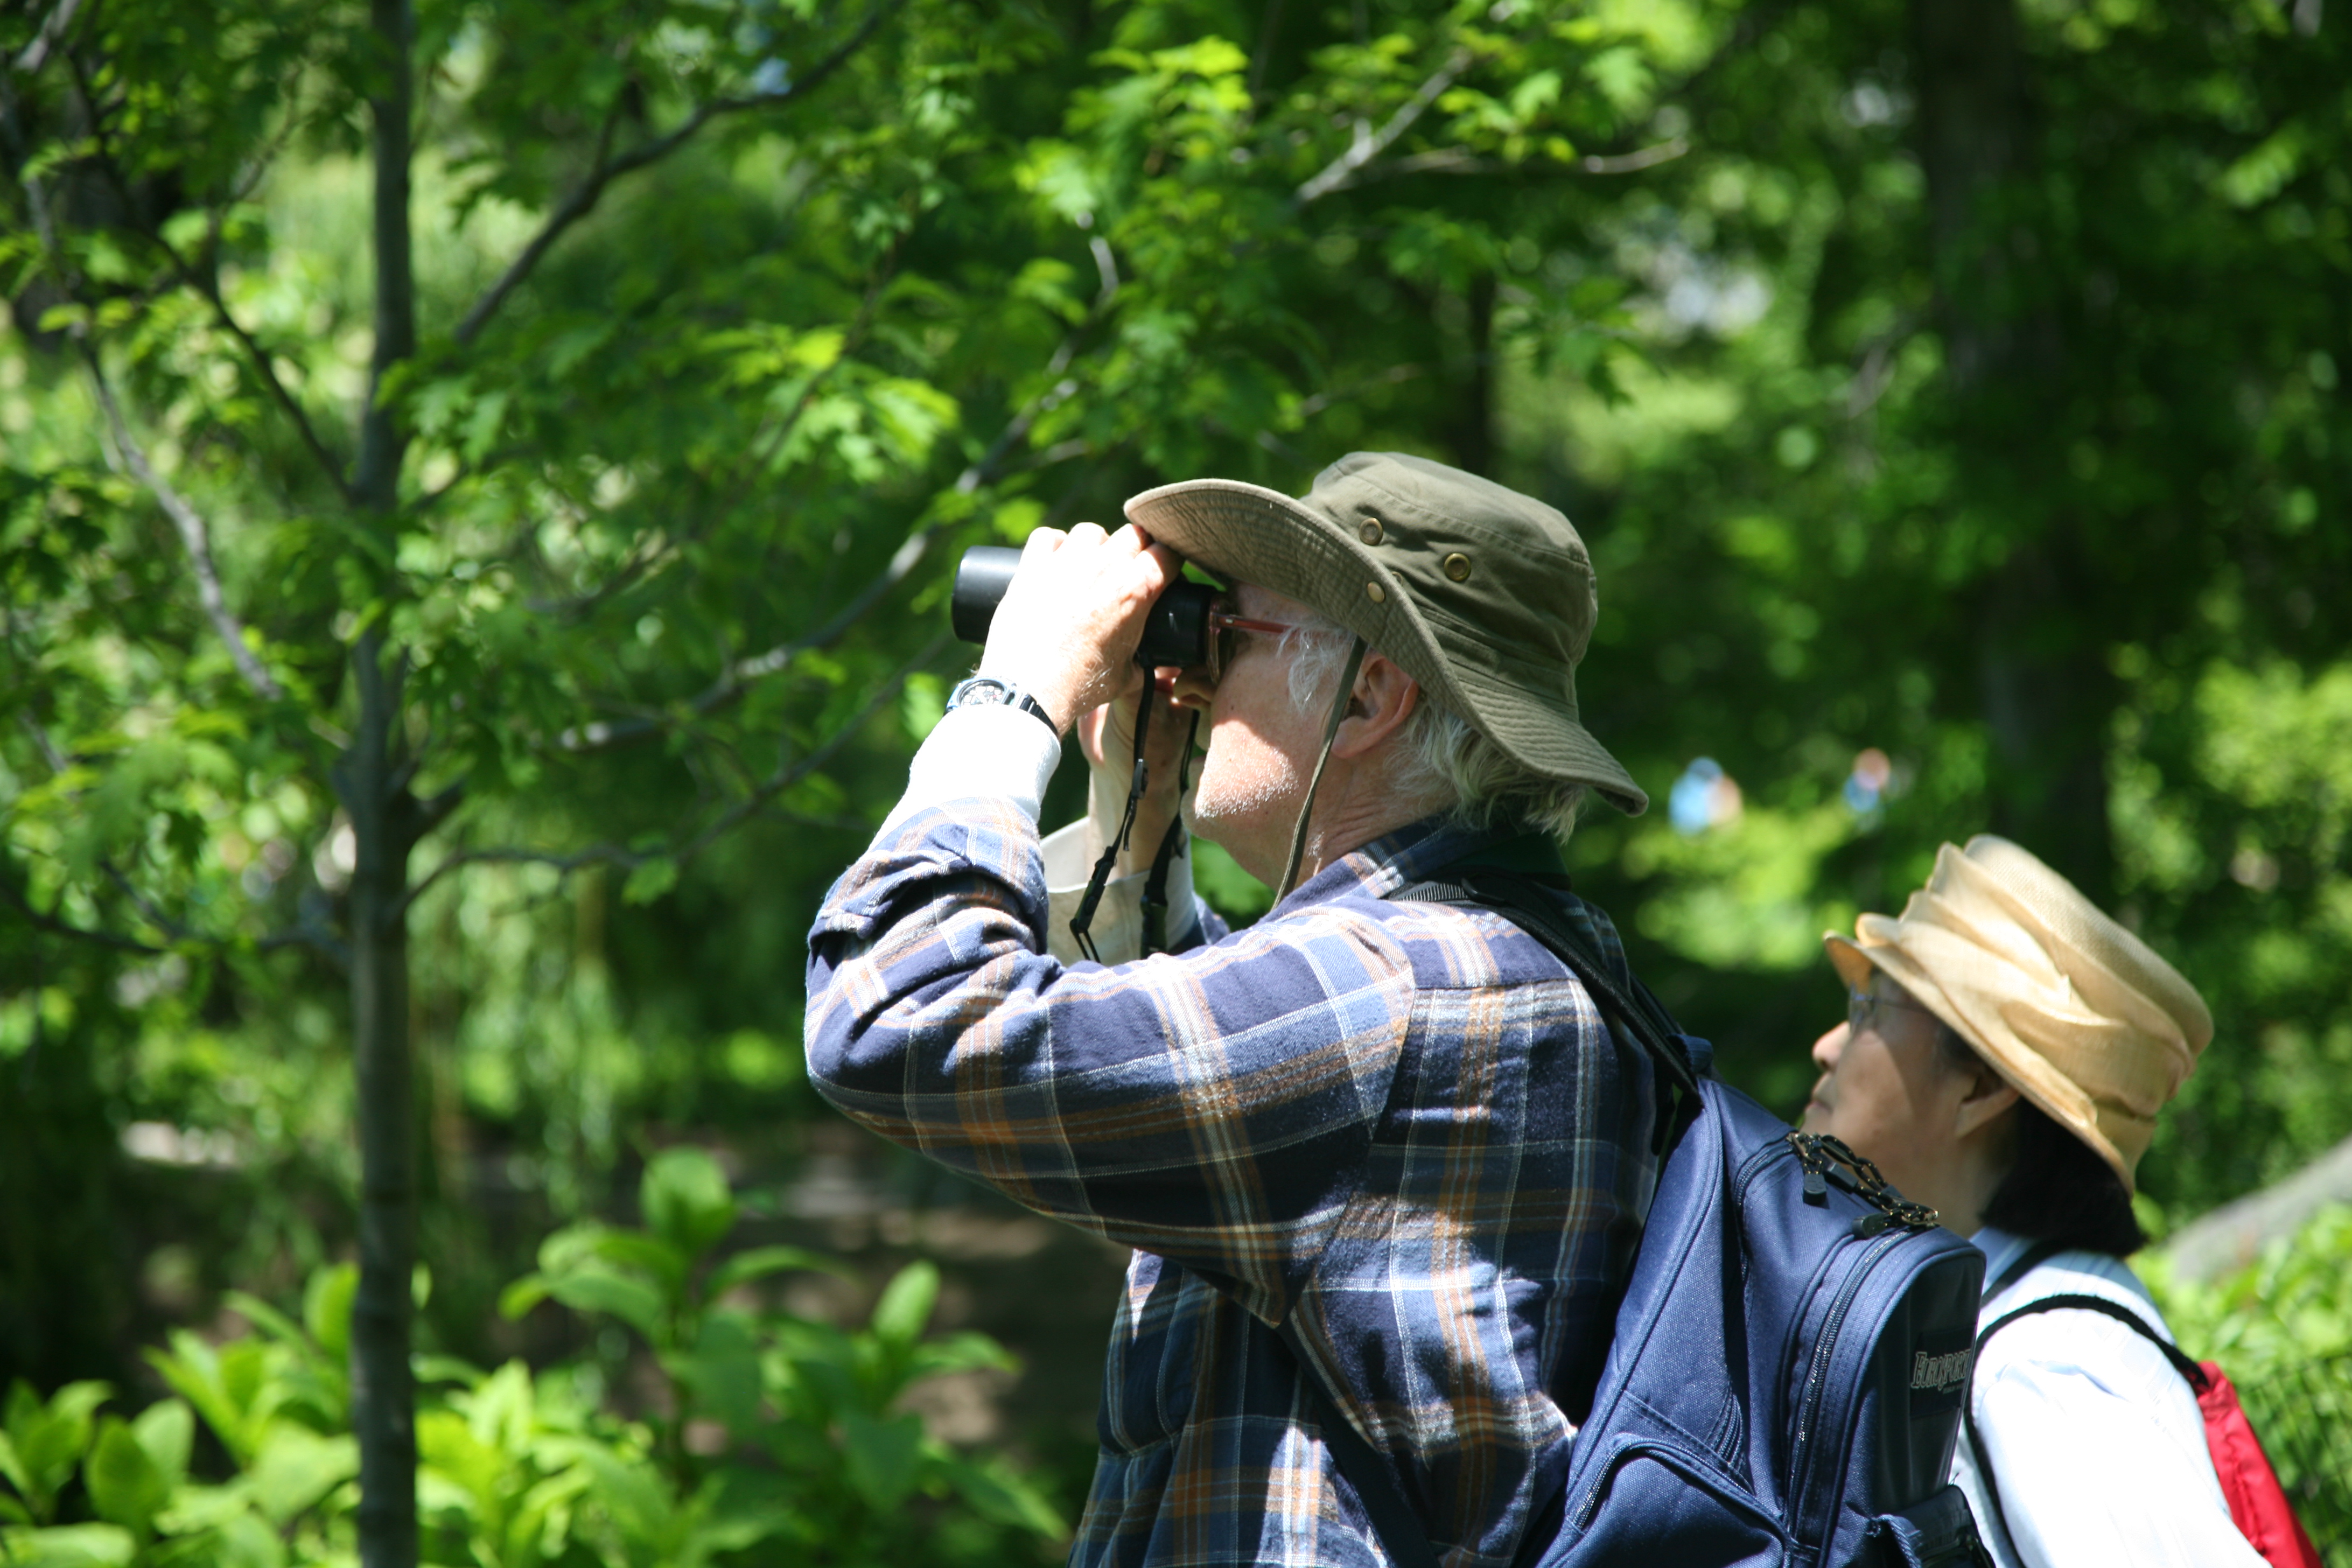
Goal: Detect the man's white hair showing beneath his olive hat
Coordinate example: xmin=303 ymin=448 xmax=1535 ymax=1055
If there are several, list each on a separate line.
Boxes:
xmin=1282 ymin=616 xmax=1585 ymax=839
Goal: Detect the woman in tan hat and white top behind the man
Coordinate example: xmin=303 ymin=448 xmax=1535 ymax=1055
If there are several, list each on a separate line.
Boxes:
xmin=1804 ymin=835 xmax=2263 ymax=1568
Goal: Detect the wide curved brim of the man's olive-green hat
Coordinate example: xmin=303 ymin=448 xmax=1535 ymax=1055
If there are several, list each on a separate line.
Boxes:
xmin=1126 ymin=480 xmax=1649 ymax=816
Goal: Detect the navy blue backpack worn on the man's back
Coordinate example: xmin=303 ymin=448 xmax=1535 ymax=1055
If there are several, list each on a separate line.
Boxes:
xmin=1308 ymin=872 xmax=1990 ymax=1568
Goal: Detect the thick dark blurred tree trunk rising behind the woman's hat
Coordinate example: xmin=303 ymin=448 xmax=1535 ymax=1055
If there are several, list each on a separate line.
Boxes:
xmin=1912 ymin=0 xmax=2117 ymax=902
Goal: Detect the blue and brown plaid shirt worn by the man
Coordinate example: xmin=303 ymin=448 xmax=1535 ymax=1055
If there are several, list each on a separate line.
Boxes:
xmin=807 ymin=799 xmax=1656 ymax=1568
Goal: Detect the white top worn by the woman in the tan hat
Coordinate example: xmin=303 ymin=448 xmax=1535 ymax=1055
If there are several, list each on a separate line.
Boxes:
xmin=1952 ymin=1227 xmax=2265 ymax=1568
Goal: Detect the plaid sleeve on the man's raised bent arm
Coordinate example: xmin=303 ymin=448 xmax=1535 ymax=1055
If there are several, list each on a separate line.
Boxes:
xmin=807 ymin=799 xmax=1413 ymax=1317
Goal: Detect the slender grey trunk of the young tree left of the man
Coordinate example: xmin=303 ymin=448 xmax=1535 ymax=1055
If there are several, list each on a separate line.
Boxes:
xmin=337 ymin=0 xmax=416 ymax=1568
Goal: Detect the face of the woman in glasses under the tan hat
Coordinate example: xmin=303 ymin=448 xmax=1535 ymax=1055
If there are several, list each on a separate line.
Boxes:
xmin=1804 ymin=971 xmax=1973 ymax=1208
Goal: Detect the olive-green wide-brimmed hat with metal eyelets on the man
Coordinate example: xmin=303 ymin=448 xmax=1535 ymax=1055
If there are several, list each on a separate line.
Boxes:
xmin=1126 ymin=451 xmax=1649 ymax=811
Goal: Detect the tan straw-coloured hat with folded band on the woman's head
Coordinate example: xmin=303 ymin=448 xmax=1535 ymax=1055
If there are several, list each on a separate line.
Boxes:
xmin=1823 ymin=832 xmax=2213 ymax=1192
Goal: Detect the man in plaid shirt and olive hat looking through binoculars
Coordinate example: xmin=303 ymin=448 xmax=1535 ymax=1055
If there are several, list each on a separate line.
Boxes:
xmin=807 ymin=454 xmax=1661 ymax=1568
